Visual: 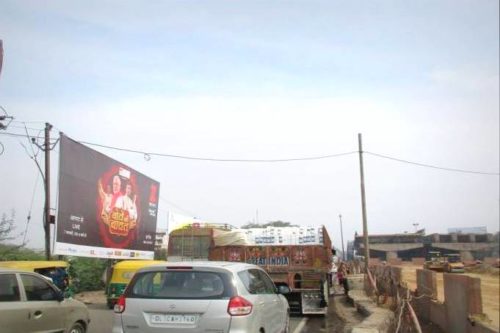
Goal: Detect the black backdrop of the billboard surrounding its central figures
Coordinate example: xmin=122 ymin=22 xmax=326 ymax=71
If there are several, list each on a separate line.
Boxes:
xmin=56 ymin=133 xmax=159 ymax=251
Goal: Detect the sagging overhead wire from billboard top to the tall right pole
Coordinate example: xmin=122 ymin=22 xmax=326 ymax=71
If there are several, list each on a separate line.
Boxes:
xmin=78 ymin=141 xmax=357 ymax=163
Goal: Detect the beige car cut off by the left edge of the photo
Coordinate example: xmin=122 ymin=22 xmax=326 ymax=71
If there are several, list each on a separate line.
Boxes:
xmin=0 ymin=268 xmax=90 ymax=333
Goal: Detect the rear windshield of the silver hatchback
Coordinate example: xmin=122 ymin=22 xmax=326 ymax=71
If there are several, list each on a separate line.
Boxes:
xmin=126 ymin=271 xmax=232 ymax=299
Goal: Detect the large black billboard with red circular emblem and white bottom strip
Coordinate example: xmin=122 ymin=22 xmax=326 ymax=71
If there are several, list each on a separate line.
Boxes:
xmin=54 ymin=133 xmax=160 ymax=259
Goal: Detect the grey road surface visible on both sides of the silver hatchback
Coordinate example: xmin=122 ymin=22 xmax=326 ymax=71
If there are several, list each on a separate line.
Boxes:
xmin=87 ymin=303 xmax=342 ymax=333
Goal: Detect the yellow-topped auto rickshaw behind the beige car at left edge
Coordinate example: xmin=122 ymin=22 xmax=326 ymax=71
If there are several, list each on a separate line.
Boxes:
xmin=0 ymin=260 xmax=69 ymax=291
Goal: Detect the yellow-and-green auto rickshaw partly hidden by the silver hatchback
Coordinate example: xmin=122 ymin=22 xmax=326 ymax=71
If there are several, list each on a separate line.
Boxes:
xmin=106 ymin=260 xmax=165 ymax=309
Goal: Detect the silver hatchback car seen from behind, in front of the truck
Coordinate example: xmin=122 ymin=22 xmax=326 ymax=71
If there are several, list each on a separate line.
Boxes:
xmin=112 ymin=261 xmax=290 ymax=333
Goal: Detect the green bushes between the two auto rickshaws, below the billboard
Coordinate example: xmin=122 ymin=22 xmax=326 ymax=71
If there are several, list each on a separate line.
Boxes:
xmin=69 ymin=257 xmax=106 ymax=293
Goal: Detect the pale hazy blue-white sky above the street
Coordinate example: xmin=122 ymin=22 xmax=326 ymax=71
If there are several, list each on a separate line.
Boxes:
xmin=0 ymin=0 xmax=500 ymax=248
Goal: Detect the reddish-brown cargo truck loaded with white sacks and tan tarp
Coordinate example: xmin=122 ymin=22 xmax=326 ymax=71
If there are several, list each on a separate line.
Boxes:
xmin=168 ymin=225 xmax=333 ymax=315
